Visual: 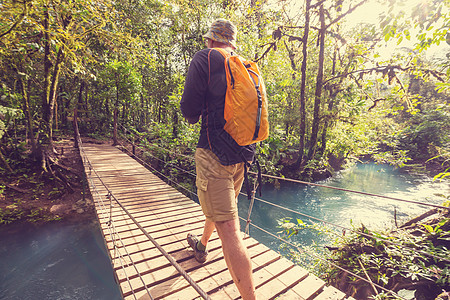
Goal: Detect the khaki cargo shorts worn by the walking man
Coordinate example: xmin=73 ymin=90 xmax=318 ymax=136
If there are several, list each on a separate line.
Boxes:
xmin=195 ymin=148 xmax=244 ymax=222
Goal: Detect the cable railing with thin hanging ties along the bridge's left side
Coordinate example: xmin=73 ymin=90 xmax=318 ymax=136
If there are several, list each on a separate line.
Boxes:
xmin=78 ymin=135 xmax=210 ymax=299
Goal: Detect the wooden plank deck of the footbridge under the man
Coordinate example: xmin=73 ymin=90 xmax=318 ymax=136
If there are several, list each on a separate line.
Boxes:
xmin=82 ymin=144 xmax=354 ymax=300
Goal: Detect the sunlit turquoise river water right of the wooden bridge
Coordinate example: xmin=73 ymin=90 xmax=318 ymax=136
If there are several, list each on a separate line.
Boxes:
xmin=239 ymin=163 xmax=450 ymax=250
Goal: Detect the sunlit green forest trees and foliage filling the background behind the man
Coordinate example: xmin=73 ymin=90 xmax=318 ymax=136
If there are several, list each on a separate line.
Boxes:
xmin=0 ymin=0 xmax=450 ymax=179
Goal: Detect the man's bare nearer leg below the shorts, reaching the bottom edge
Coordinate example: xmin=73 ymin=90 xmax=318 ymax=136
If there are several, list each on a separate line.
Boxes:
xmin=216 ymin=219 xmax=256 ymax=300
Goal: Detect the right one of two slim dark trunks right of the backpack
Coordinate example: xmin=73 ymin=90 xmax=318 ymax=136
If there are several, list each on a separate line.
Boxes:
xmin=307 ymin=4 xmax=325 ymax=161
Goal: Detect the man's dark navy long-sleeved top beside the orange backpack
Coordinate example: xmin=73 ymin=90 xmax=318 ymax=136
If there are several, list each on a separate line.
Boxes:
xmin=180 ymin=49 xmax=255 ymax=166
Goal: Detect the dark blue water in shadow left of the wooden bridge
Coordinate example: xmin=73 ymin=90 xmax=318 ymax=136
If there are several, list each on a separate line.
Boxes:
xmin=0 ymin=222 xmax=121 ymax=300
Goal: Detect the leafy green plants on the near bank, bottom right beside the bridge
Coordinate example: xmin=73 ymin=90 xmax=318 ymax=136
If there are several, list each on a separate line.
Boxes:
xmin=279 ymin=197 xmax=450 ymax=299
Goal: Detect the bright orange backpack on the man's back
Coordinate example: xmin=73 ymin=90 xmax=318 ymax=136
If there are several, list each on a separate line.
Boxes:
xmin=214 ymin=48 xmax=269 ymax=146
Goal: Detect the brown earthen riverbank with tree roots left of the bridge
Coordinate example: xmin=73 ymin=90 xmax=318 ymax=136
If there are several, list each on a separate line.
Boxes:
xmin=0 ymin=137 xmax=95 ymax=226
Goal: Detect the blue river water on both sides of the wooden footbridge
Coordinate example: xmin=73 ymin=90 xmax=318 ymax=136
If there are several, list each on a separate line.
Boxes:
xmin=0 ymin=163 xmax=450 ymax=300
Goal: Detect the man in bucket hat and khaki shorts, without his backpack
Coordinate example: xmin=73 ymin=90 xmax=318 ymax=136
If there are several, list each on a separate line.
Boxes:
xmin=180 ymin=19 xmax=255 ymax=300
